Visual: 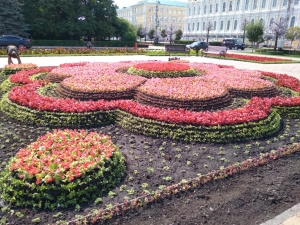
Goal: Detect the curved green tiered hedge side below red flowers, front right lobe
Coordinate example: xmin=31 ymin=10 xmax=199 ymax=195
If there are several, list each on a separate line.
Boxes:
xmin=116 ymin=110 xmax=281 ymax=143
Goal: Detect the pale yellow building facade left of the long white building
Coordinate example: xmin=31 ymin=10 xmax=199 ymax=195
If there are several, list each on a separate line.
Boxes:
xmin=117 ymin=0 xmax=186 ymax=32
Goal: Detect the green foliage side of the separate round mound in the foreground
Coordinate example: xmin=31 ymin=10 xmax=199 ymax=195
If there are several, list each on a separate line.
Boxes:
xmin=0 ymin=150 xmax=126 ymax=210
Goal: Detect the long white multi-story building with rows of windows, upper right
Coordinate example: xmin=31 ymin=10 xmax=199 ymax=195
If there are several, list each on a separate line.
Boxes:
xmin=183 ymin=0 xmax=300 ymax=40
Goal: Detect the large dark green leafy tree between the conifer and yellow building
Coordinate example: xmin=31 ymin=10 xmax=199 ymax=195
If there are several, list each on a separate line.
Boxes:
xmin=23 ymin=0 xmax=117 ymax=40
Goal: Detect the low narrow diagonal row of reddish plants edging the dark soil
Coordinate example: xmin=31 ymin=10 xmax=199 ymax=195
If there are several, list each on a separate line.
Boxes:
xmin=67 ymin=143 xmax=300 ymax=225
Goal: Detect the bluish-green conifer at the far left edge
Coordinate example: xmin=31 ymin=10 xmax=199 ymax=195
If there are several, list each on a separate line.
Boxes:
xmin=0 ymin=0 xmax=29 ymax=37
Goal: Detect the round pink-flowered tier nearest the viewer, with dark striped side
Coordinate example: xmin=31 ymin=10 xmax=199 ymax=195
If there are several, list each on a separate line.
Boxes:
xmin=136 ymin=77 xmax=232 ymax=111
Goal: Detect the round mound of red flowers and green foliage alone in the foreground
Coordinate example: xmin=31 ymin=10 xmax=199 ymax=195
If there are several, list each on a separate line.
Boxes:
xmin=0 ymin=130 xmax=125 ymax=209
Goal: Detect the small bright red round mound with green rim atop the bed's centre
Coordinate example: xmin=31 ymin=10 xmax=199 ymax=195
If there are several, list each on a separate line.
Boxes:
xmin=127 ymin=62 xmax=197 ymax=78
